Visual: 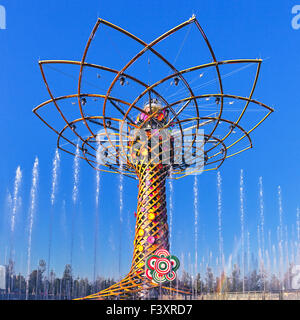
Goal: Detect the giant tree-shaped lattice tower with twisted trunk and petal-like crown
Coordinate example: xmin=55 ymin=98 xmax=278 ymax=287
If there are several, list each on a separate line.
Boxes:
xmin=33 ymin=16 xmax=273 ymax=299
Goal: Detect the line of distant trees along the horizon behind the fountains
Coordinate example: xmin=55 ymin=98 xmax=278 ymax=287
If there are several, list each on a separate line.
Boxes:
xmin=0 ymin=260 xmax=292 ymax=300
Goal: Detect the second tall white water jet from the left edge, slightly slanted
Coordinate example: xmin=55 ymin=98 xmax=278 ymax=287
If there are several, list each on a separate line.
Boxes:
xmin=26 ymin=158 xmax=39 ymax=300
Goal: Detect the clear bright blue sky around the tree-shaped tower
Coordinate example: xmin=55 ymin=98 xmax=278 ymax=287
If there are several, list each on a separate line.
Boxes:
xmin=0 ymin=0 xmax=300 ymax=277
